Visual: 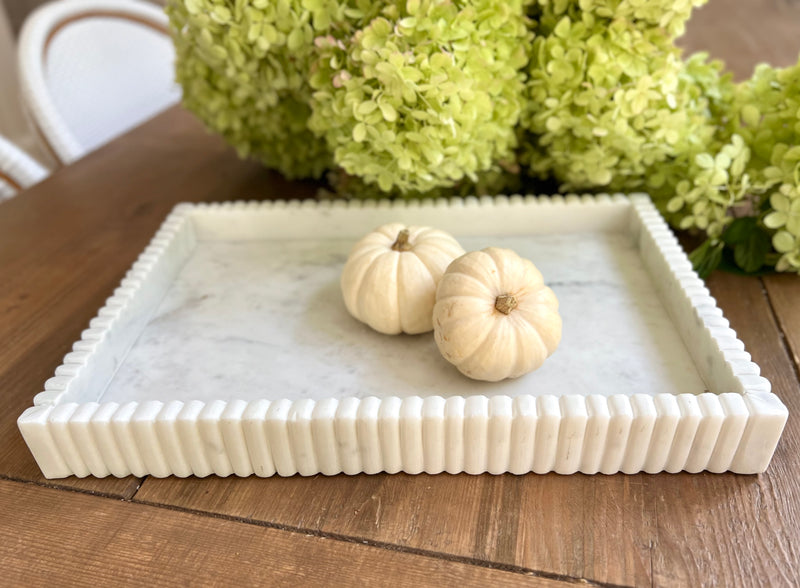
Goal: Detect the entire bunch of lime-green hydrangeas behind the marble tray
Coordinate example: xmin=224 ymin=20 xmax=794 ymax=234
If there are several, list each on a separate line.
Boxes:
xmin=167 ymin=0 xmax=800 ymax=272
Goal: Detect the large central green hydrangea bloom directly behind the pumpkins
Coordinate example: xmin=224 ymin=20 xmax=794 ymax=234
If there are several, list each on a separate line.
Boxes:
xmin=309 ymin=0 xmax=531 ymax=193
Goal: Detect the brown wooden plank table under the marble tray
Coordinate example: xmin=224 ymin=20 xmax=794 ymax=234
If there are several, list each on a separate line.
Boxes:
xmin=0 ymin=0 xmax=800 ymax=586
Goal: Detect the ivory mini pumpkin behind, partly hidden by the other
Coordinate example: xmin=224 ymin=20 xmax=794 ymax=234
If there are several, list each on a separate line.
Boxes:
xmin=341 ymin=223 xmax=464 ymax=335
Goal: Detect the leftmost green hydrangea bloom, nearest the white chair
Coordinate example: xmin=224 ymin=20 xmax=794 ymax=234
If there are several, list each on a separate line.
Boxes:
xmin=166 ymin=0 xmax=347 ymax=177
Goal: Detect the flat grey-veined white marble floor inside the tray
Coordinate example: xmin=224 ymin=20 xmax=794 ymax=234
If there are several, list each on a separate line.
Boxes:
xmin=101 ymin=233 xmax=706 ymax=402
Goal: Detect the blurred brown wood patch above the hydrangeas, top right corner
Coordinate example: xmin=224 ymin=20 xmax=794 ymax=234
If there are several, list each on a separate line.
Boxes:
xmin=678 ymin=0 xmax=800 ymax=80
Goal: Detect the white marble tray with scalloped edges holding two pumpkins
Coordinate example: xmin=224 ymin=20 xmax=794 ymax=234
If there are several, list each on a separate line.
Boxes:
xmin=18 ymin=195 xmax=787 ymax=478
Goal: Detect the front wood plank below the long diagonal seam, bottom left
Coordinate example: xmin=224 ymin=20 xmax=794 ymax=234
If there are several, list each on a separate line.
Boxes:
xmin=0 ymin=481 xmax=566 ymax=587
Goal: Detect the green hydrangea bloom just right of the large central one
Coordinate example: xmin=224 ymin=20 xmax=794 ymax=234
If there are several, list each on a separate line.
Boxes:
xmin=522 ymin=10 xmax=722 ymax=199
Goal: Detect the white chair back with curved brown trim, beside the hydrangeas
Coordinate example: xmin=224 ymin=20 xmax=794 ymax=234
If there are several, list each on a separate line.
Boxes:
xmin=18 ymin=0 xmax=181 ymax=164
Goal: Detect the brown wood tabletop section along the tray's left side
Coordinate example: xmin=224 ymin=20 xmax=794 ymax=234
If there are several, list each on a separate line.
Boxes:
xmin=0 ymin=108 xmax=315 ymax=497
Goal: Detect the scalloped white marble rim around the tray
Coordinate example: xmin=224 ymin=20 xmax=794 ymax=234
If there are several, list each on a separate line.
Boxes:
xmin=18 ymin=194 xmax=788 ymax=478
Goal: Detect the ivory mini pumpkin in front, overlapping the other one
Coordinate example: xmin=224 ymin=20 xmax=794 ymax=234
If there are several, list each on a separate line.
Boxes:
xmin=433 ymin=247 xmax=561 ymax=382
